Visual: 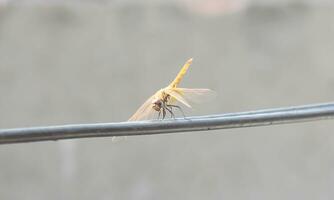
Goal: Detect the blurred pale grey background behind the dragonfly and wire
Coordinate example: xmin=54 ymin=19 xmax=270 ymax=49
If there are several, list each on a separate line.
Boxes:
xmin=0 ymin=0 xmax=334 ymax=200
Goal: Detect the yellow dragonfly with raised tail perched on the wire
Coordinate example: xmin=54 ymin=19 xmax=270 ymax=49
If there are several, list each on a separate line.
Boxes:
xmin=129 ymin=58 xmax=213 ymax=121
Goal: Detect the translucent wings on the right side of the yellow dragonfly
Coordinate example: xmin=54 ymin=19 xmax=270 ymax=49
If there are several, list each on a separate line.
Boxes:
xmin=165 ymin=88 xmax=215 ymax=108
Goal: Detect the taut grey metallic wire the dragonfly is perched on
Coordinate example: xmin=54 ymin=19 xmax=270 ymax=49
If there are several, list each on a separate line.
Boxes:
xmin=0 ymin=103 xmax=334 ymax=144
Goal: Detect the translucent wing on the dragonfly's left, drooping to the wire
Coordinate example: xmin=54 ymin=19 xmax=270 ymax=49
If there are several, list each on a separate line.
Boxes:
xmin=128 ymin=95 xmax=156 ymax=121
